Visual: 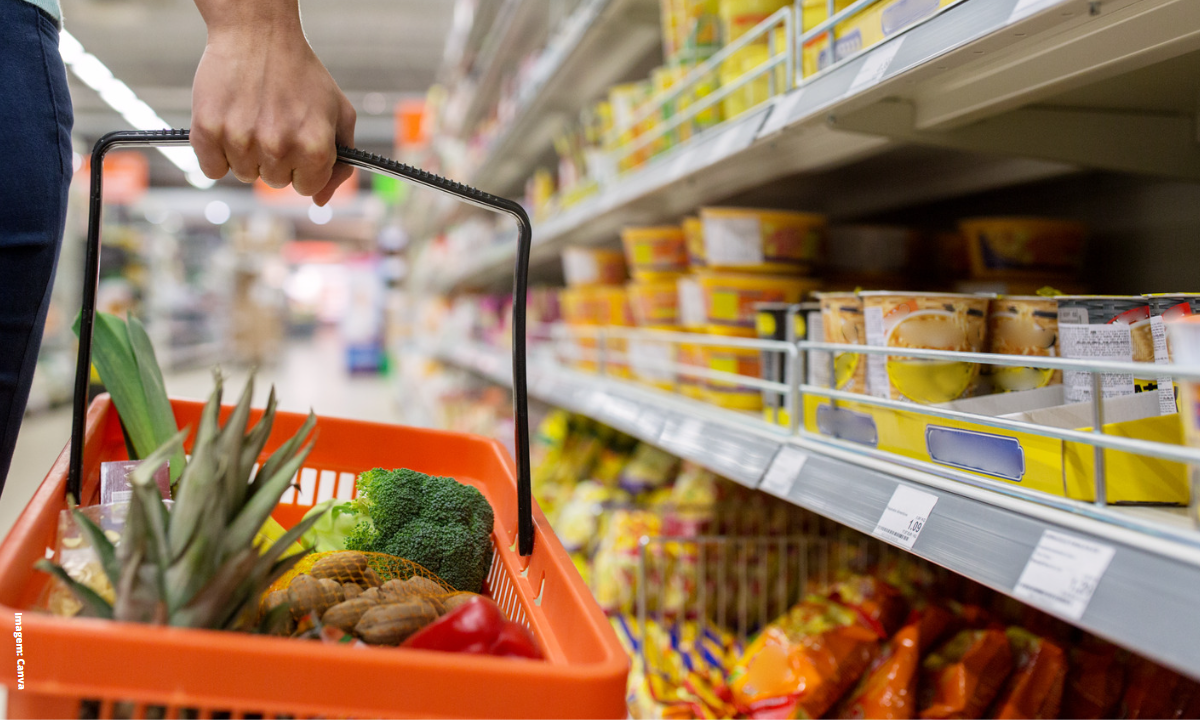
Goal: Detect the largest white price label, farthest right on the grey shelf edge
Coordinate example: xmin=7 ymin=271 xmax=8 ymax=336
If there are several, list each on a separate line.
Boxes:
xmin=1013 ymin=530 xmax=1116 ymax=620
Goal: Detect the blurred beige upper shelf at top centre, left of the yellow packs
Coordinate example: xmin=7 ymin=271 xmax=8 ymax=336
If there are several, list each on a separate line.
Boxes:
xmin=468 ymin=0 xmax=660 ymax=193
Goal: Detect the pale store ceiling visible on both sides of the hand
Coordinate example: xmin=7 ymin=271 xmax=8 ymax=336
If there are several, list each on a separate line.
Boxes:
xmin=62 ymin=0 xmax=463 ymax=182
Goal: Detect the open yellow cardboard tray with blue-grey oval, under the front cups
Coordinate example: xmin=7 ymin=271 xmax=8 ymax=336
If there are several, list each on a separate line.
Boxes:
xmin=804 ymin=386 xmax=1189 ymax=505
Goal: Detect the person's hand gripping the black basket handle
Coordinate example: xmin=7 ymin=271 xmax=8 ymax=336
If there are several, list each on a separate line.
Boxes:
xmin=191 ymin=0 xmax=355 ymax=205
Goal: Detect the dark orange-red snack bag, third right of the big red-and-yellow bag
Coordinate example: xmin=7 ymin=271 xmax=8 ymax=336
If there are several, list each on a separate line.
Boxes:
xmin=991 ymin=628 xmax=1067 ymax=719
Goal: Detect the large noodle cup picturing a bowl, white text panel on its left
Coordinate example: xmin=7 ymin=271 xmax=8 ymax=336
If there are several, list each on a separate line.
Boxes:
xmin=860 ymin=292 xmax=989 ymax=403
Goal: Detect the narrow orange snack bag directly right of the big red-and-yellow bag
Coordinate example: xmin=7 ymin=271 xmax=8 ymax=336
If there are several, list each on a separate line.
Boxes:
xmin=838 ymin=622 xmax=920 ymax=720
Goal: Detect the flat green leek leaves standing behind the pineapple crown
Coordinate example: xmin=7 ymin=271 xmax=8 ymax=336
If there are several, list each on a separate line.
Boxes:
xmin=74 ymin=312 xmax=187 ymax=485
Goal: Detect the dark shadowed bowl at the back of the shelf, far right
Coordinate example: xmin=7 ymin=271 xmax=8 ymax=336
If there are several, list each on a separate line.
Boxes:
xmin=959 ymin=217 xmax=1087 ymax=278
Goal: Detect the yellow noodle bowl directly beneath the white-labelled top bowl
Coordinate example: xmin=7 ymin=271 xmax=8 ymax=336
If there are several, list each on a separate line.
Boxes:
xmin=696 ymin=272 xmax=821 ymax=337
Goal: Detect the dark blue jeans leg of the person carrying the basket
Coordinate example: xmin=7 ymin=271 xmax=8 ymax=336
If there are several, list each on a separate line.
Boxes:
xmin=0 ymin=0 xmax=74 ymax=491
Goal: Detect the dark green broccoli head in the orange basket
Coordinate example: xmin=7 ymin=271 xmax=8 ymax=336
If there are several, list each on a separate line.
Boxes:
xmin=346 ymin=468 xmax=494 ymax=593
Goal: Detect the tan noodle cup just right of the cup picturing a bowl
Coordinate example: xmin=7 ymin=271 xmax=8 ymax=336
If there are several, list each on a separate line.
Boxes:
xmin=986 ymin=295 xmax=1062 ymax=392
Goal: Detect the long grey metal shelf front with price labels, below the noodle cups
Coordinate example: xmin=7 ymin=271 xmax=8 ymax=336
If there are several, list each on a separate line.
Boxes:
xmin=427 ymin=343 xmax=1200 ymax=677
